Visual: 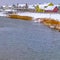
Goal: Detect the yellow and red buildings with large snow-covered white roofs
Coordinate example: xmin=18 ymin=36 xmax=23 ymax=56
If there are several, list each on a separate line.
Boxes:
xmin=32 ymin=3 xmax=59 ymax=12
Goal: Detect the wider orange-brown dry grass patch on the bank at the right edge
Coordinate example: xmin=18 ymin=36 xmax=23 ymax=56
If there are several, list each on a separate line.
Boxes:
xmin=41 ymin=18 xmax=60 ymax=31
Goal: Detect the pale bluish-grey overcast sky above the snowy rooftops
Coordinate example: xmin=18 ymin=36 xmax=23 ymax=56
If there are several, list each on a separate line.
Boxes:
xmin=0 ymin=0 xmax=60 ymax=5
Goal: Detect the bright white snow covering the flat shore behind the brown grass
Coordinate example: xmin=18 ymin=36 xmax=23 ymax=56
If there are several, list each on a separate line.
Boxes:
xmin=0 ymin=12 xmax=60 ymax=21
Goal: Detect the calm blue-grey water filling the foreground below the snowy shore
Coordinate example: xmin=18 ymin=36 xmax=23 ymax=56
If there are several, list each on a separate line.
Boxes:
xmin=0 ymin=17 xmax=60 ymax=60
